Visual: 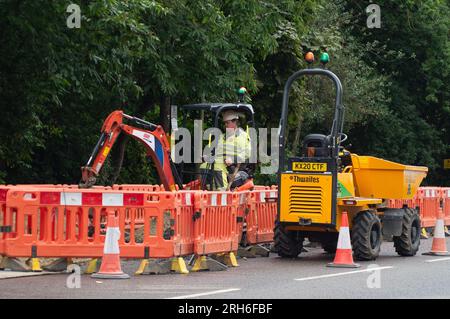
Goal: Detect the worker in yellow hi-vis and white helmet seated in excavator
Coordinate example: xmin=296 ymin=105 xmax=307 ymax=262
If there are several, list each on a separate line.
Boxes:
xmin=200 ymin=110 xmax=251 ymax=190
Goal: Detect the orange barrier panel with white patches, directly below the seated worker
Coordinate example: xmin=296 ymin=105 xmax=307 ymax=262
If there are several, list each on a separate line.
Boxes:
xmin=194 ymin=191 xmax=239 ymax=255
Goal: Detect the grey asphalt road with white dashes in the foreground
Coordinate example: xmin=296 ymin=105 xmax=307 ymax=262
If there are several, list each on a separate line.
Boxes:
xmin=0 ymin=238 xmax=450 ymax=299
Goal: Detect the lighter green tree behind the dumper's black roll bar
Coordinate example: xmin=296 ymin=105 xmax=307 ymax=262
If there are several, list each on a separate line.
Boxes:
xmin=253 ymin=2 xmax=389 ymax=158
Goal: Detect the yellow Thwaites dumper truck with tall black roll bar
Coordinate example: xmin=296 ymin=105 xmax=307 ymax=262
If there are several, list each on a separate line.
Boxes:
xmin=274 ymin=63 xmax=428 ymax=260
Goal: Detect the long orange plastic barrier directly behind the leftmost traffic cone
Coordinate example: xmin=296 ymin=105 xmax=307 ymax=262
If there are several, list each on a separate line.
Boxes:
xmin=0 ymin=186 xmax=193 ymax=258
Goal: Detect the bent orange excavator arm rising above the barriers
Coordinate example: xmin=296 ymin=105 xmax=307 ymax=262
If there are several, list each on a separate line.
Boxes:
xmin=80 ymin=111 xmax=183 ymax=190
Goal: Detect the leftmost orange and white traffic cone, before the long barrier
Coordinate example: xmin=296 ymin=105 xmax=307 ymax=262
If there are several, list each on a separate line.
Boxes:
xmin=91 ymin=211 xmax=130 ymax=279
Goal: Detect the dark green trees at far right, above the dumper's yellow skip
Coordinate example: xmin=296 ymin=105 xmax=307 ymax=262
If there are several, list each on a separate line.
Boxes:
xmin=346 ymin=0 xmax=450 ymax=185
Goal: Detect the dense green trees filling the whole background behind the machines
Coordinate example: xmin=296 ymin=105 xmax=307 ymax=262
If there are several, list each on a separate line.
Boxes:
xmin=0 ymin=0 xmax=450 ymax=185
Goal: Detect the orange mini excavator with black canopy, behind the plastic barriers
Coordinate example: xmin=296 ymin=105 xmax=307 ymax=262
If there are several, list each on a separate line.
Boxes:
xmin=79 ymin=94 xmax=254 ymax=191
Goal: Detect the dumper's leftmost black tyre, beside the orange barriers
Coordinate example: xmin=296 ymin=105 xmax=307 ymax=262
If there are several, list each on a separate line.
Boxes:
xmin=274 ymin=220 xmax=304 ymax=258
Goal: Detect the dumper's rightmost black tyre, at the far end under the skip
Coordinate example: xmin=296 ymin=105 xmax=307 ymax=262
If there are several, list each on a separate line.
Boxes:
xmin=394 ymin=208 xmax=420 ymax=256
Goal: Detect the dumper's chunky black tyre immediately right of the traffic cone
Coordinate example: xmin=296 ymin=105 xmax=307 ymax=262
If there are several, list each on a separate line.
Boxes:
xmin=352 ymin=211 xmax=383 ymax=260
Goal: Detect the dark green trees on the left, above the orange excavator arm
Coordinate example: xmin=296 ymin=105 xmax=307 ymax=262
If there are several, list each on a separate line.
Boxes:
xmin=0 ymin=0 xmax=322 ymax=183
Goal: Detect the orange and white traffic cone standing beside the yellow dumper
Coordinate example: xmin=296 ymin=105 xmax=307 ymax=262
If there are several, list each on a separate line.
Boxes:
xmin=327 ymin=212 xmax=361 ymax=268
